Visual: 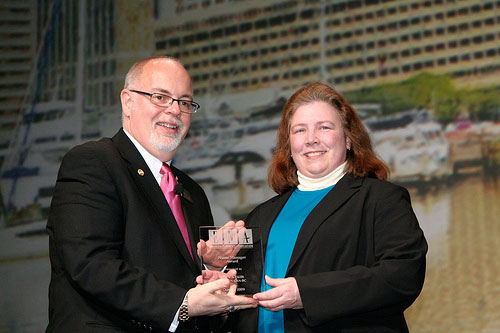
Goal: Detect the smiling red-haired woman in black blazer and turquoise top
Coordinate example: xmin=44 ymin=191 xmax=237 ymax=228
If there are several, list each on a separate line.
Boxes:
xmin=232 ymin=83 xmax=427 ymax=332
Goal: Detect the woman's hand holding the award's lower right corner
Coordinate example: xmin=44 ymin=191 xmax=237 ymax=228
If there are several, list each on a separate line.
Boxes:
xmin=253 ymin=275 xmax=304 ymax=311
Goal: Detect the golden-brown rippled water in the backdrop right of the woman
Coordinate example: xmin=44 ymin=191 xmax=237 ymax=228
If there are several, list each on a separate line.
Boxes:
xmin=406 ymin=175 xmax=500 ymax=332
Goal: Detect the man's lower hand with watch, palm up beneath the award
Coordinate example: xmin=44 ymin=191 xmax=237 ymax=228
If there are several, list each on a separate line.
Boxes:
xmin=187 ymin=278 xmax=257 ymax=317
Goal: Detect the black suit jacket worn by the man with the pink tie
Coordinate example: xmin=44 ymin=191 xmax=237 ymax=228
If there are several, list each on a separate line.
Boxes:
xmin=47 ymin=130 xmax=213 ymax=332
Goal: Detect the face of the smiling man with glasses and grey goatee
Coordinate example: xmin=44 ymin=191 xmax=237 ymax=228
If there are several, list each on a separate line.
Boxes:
xmin=121 ymin=59 xmax=193 ymax=162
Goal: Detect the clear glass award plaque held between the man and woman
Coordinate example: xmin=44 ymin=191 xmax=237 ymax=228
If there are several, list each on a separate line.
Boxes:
xmin=200 ymin=226 xmax=264 ymax=296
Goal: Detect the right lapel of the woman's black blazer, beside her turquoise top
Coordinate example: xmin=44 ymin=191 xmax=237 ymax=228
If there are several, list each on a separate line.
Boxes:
xmin=287 ymin=175 xmax=361 ymax=274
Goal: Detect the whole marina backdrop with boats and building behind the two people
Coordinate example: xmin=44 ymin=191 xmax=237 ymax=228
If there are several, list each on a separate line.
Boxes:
xmin=0 ymin=0 xmax=500 ymax=332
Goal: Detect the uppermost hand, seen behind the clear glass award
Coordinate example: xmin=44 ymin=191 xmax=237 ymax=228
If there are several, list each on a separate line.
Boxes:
xmin=197 ymin=220 xmax=246 ymax=270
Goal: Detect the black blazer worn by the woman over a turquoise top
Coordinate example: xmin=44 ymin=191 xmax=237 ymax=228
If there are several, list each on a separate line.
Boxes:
xmin=232 ymin=175 xmax=427 ymax=332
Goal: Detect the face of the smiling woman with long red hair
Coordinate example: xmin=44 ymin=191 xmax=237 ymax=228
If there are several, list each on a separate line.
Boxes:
xmin=290 ymin=101 xmax=351 ymax=178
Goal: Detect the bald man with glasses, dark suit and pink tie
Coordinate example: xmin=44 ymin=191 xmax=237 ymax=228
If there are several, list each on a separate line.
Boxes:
xmin=47 ymin=57 xmax=255 ymax=332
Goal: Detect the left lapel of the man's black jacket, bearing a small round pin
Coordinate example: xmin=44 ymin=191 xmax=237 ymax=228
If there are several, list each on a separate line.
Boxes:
xmin=113 ymin=129 xmax=199 ymax=274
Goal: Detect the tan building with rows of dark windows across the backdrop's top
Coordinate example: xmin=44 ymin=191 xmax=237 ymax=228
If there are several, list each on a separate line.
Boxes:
xmin=155 ymin=0 xmax=500 ymax=95
